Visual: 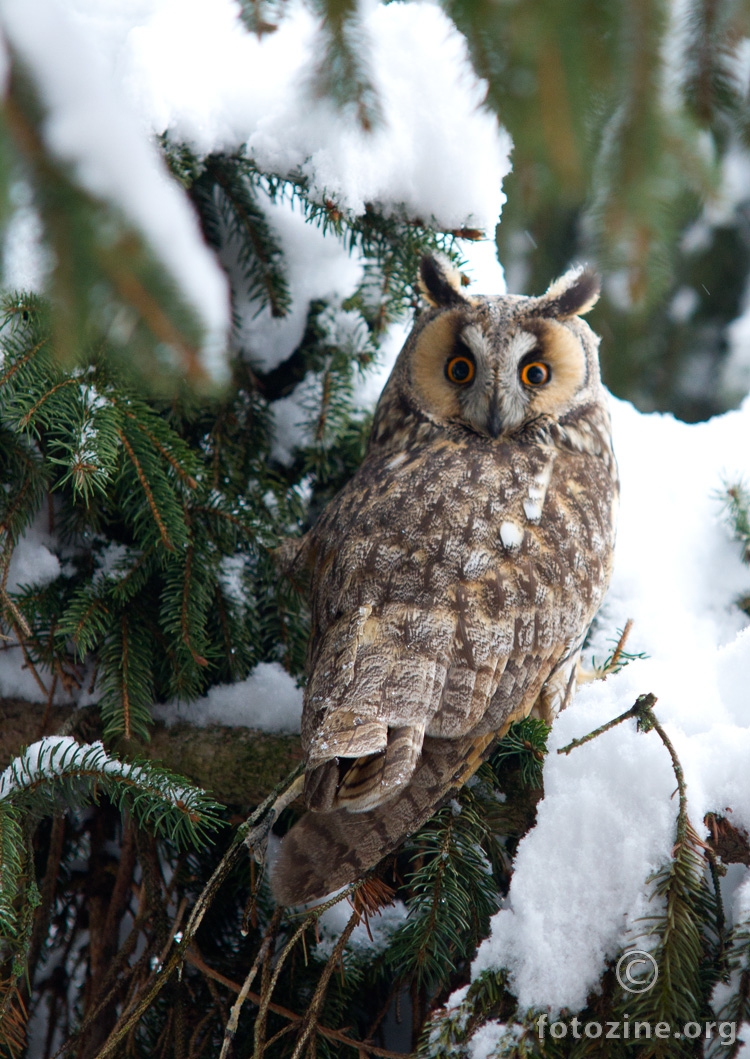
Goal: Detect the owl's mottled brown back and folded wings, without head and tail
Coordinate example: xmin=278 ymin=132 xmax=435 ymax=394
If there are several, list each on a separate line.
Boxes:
xmin=292 ymin=417 xmax=613 ymax=810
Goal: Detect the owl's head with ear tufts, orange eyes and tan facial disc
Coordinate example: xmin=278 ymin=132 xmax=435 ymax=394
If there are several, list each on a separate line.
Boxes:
xmin=376 ymin=257 xmax=602 ymax=438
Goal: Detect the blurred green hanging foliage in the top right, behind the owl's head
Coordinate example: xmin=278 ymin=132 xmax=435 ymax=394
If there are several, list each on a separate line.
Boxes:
xmin=447 ymin=0 xmax=750 ymax=419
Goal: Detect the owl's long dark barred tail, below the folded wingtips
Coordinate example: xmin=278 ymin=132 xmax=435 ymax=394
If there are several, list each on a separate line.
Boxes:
xmin=271 ymin=734 xmax=497 ymax=905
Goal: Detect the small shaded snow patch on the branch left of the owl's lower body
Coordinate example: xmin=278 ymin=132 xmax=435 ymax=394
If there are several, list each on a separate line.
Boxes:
xmin=154 ymin=662 xmax=302 ymax=733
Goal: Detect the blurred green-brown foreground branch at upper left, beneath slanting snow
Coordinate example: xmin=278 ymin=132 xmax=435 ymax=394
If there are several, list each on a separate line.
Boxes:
xmin=0 ymin=69 xmax=209 ymax=389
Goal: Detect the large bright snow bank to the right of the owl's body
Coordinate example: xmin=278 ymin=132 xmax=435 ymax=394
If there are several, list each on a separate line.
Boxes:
xmin=472 ymin=398 xmax=750 ymax=1012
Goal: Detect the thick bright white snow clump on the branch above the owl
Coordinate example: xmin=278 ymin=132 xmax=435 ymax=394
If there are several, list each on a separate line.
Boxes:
xmin=61 ymin=0 xmax=511 ymax=234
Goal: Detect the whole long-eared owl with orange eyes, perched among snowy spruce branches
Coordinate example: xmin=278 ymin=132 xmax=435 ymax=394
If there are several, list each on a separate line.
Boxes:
xmin=272 ymin=257 xmax=618 ymax=904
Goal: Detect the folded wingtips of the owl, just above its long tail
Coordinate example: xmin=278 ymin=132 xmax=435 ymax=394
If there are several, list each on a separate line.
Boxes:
xmin=305 ymin=715 xmax=425 ymax=812
